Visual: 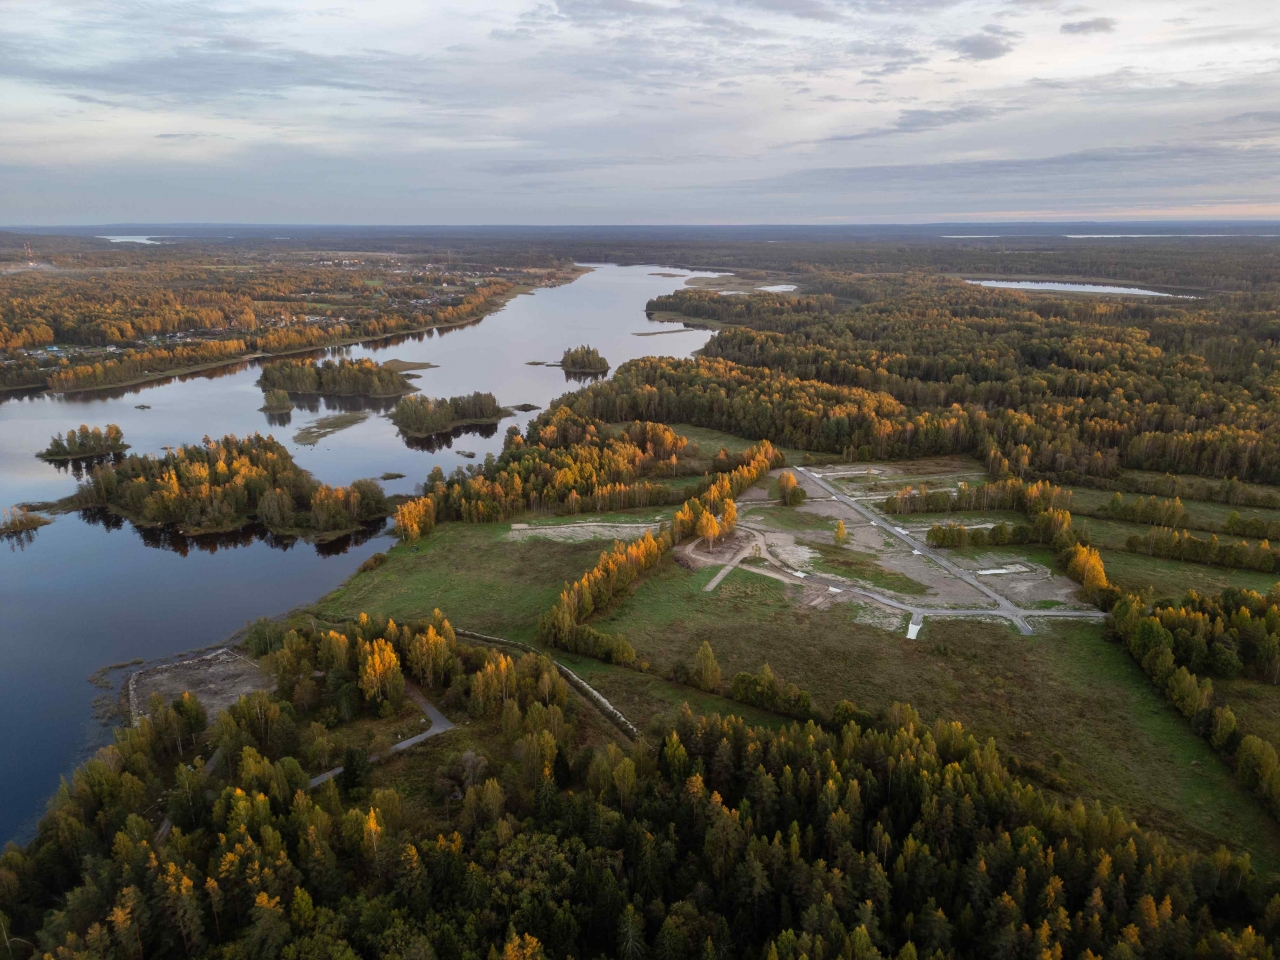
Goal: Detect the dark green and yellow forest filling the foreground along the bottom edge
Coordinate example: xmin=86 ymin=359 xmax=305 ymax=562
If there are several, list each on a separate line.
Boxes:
xmin=0 ymin=691 xmax=1280 ymax=960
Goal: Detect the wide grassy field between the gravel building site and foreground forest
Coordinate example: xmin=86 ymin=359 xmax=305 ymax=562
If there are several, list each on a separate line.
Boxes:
xmin=593 ymin=552 xmax=1280 ymax=868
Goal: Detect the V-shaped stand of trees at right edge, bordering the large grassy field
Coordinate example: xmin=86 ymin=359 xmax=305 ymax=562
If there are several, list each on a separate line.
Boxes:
xmin=1108 ymin=588 xmax=1280 ymax=818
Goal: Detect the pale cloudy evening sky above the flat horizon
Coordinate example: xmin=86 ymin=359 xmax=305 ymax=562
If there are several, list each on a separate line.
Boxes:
xmin=0 ymin=0 xmax=1280 ymax=225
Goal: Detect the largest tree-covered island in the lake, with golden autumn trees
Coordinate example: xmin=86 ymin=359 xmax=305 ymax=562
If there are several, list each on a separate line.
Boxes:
xmin=76 ymin=434 xmax=388 ymax=532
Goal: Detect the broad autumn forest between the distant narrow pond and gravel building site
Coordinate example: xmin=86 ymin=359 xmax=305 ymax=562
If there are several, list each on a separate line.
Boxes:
xmin=588 ymin=278 xmax=1280 ymax=484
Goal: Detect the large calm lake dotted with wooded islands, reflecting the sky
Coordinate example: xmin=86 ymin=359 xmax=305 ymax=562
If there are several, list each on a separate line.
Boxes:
xmin=0 ymin=265 xmax=710 ymax=842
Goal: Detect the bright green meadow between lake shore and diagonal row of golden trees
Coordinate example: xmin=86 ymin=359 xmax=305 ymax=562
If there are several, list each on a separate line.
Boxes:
xmin=314 ymin=524 xmax=600 ymax=641
